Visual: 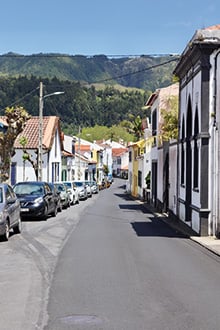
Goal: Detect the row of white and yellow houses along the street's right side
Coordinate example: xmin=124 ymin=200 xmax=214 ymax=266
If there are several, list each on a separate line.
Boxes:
xmin=127 ymin=25 xmax=220 ymax=237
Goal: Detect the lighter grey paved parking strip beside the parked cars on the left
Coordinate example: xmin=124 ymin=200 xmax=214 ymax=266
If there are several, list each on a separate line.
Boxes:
xmin=0 ymin=188 xmax=93 ymax=330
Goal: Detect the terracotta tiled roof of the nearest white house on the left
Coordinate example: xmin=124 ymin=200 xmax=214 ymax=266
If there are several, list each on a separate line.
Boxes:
xmin=14 ymin=116 xmax=63 ymax=150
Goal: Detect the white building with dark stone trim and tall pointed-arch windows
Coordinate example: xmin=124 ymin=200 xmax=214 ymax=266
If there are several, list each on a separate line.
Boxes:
xmin=174 ymin=25 xmax=220 ymax=236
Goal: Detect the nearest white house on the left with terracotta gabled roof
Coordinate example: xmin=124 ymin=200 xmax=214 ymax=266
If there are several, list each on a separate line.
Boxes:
xmin=11 ymin=116 xmax=63 ymax=184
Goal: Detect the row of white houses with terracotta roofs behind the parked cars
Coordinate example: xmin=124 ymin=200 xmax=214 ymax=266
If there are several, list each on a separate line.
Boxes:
xmin=0 ymin=116 xmax=128 ymax=185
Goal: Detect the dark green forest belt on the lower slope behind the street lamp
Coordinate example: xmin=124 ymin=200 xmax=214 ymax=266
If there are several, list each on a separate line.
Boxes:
xmin=0 ymin=76 xmax=149 ymax=135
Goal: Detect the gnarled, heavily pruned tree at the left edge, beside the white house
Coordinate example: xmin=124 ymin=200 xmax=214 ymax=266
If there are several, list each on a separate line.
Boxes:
xmin=0 ymin=106 xmax=30 ymax=182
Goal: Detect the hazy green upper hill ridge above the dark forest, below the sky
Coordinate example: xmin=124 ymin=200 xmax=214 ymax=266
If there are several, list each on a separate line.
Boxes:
xmin=0 ymin=53 xmax=177 ymax=91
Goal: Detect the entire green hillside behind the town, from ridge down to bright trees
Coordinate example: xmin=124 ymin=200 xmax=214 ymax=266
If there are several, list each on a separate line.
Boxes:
xmin=0 ymin=53 xmax=178 ymax=141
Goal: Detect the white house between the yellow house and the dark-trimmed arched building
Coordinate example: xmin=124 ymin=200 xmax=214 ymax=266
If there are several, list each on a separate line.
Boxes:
xmin=147 ymin=83 xmax=179 ymax=213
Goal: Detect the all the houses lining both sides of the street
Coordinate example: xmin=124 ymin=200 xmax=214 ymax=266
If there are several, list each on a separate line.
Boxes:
xmin=0 ymin=25 xmax=220 ymax=237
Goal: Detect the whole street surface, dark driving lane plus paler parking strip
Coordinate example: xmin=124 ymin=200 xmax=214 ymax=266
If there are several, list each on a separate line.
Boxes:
xmin=0 ymin=179 xmax=220 ymax=330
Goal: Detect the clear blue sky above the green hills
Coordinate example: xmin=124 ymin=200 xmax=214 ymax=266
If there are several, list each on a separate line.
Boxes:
xmin=0 ymin=0 xmax=220 ymax=57
